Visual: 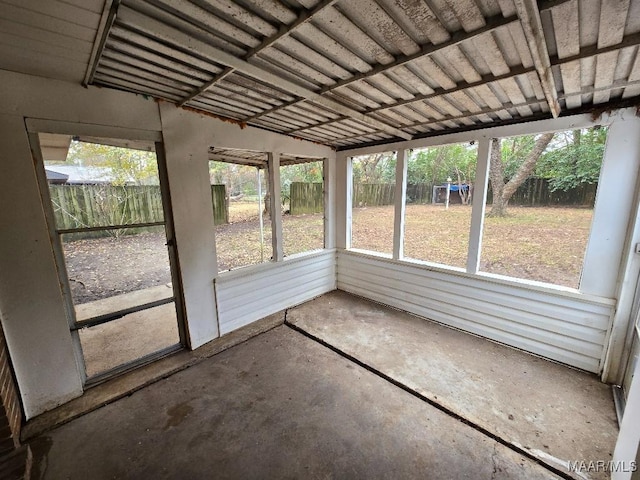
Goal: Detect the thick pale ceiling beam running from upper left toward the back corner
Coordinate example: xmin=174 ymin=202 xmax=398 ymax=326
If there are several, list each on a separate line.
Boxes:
xmin=118 ymin=7 xmax=411 ymax=140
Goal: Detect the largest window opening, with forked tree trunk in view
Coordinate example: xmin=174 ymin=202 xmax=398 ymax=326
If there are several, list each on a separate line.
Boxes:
xmin=480 ymin=128 xmax=607 ymax=288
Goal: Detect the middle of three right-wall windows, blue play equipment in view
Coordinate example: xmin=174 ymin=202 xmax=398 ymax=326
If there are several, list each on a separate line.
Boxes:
xmin=404 ymin=143 xmax=477 ymax=268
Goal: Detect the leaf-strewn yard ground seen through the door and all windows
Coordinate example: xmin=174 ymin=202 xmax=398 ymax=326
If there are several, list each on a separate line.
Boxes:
xmin=64 ymin=205 xmax=593 ymax=303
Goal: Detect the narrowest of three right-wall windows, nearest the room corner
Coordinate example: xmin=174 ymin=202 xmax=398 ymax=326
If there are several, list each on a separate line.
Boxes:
xmin=351 ymin=152 xmax=397 ymax=255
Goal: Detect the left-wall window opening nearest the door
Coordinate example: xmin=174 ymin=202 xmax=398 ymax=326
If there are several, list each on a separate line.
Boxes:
xmin=209 ymin=161 xmax=272 ymax=272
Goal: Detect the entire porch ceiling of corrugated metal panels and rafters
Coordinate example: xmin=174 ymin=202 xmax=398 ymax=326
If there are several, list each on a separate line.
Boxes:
xmin=0 ymin=0 xmax=640 ymax=149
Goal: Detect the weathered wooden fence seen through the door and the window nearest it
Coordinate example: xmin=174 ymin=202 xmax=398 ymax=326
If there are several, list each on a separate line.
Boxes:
xmin=49 ymin=185 xmax=228 ymax=238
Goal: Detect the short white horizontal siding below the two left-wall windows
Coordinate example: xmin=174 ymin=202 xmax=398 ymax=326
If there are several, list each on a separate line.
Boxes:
xmin=215 ymin=250 xmax=336 ymax=335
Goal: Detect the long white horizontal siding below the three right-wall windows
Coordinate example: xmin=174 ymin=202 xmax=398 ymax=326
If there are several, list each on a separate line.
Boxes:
xmin=337 ymin=252 xmax=613 ymax=373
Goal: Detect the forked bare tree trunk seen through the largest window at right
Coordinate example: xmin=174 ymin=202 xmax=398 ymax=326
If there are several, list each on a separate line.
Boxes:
xmin=489 ymin=133 xmax=554 ymax=217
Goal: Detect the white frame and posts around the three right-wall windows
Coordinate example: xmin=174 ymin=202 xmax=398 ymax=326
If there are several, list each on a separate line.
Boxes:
xmin=338 ymin=110 xmax=636 ymax=298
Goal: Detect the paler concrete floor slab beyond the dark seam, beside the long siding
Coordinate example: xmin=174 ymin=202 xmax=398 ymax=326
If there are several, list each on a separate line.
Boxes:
xmin=287 ymin=291 xmax=618 ymax=478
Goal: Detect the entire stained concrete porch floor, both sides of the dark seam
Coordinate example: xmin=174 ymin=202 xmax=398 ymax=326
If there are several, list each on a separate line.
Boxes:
xmin=31 ymin=292 xmax=617 ymax=479
